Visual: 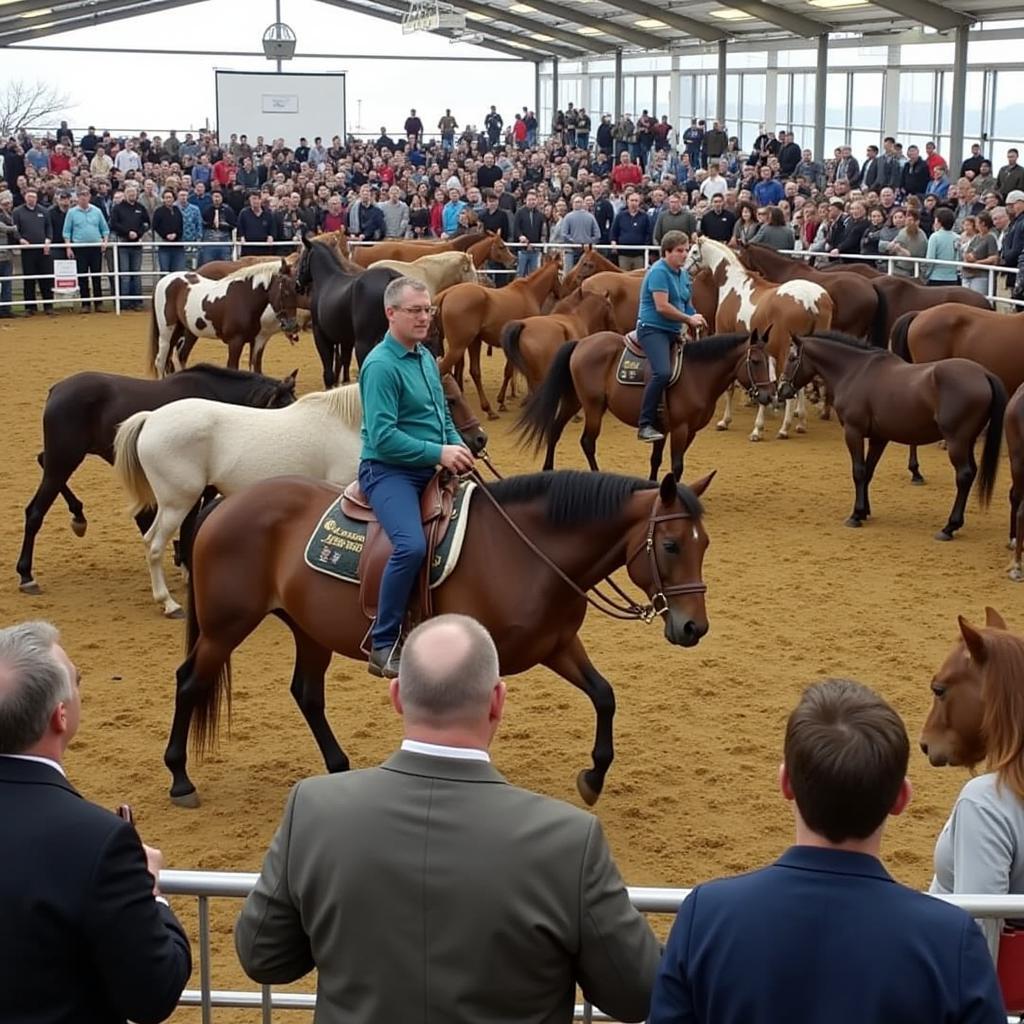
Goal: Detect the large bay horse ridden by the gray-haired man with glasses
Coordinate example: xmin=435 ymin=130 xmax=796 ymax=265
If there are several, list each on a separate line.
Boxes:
xmin=164 ymin=472 xmax=714 ymax=807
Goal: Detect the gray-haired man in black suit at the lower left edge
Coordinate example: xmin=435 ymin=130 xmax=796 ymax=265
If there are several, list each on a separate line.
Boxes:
xmin=0 ymin=623 xmax=191 ymax=1024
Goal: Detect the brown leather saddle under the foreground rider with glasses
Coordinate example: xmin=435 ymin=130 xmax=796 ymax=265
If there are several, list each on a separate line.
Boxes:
xmin=341 ymin=469 xmax=459 ymax=621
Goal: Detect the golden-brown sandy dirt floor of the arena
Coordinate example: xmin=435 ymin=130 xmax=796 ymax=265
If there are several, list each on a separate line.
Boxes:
xmin=0 ymin=313 xmax=1024 ymax=1021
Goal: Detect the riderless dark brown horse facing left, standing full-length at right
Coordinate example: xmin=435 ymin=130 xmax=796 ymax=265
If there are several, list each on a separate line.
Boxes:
xmin=779 ymin=333 xmax=1007 ymax=541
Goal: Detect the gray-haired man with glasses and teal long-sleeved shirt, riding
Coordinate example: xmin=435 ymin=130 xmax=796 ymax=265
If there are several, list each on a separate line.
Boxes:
xmin=359 ymin=278 xmax=473 ymax=679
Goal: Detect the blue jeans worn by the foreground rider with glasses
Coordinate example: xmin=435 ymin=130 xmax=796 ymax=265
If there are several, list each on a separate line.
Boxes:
xmin=359 ymin=459 xmax=434 ymax=650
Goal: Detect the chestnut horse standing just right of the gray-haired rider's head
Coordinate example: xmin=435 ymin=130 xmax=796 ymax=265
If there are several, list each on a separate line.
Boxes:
xmin=436 ymin=255 xmax=562 ymax=420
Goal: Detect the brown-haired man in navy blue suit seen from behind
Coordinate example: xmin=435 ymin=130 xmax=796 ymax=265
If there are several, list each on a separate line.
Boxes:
xmin=648 ymin=679 xmax=1006 ymax=1024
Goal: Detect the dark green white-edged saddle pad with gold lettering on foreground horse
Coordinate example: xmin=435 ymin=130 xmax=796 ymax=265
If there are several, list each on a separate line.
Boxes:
xmin=305 ymin=480 xmax=476 ymax=590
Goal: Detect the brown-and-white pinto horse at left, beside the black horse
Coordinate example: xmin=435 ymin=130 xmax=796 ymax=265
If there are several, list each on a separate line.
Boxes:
xmin=150 ymin=262 xmax=299 ymax=378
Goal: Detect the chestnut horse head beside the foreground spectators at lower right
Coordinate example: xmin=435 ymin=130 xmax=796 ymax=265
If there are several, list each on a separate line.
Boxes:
xmin=921 ymin=608 xmax=1007 ymax=768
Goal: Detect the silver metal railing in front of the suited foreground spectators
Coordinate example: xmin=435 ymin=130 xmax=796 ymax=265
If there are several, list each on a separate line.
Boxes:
xmin=160 ymin=870 xmax=1024 ymax=1024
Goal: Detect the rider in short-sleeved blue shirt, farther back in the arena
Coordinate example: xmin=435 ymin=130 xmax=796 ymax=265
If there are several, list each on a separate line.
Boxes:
xmin=637 ymin=231 xmax=708 ymax=443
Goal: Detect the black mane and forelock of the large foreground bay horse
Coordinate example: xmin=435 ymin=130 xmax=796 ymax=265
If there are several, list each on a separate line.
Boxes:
xmin=486 ymin=469 xmax=703 ymax=526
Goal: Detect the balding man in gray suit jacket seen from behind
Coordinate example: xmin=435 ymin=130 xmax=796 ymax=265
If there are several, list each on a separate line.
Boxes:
xmin=234 ymin=615 xmax=659 ymax=1024
